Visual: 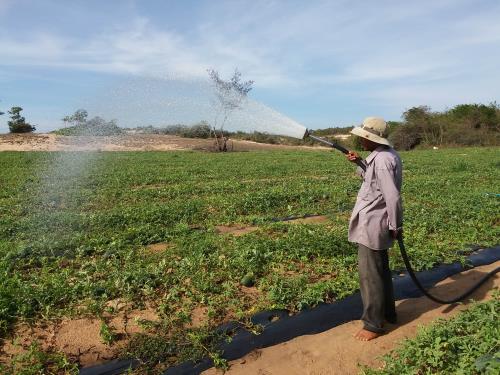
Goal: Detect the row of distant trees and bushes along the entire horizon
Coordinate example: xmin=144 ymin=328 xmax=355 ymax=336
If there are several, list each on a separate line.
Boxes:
xmin=0 ymin=102 xmax=500 ymax=150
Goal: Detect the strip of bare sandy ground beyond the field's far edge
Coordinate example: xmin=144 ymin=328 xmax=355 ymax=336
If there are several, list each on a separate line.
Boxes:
xmin=0 ymin=134 xmax=323 ymax=151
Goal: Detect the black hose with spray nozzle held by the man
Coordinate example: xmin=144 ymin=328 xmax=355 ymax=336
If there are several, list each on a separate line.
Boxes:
xmin=304 ymin=130 xmax=500 ymax=305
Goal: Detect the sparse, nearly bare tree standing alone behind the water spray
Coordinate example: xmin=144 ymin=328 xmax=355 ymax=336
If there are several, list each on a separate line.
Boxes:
xmin=207 ymin=69 xmax=254 ymax=151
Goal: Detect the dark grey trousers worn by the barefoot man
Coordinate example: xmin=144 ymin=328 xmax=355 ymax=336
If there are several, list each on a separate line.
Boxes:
xmin=358 ymin=244 xmax=396 ymax=333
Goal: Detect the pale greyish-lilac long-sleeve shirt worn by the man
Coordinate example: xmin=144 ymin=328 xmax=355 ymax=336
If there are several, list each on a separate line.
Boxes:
xmin=348 ymin=146 xmax=403 ymax=250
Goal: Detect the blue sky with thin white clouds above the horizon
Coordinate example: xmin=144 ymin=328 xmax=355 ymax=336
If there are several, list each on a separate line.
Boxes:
xmin=0 ymin=0 xmax=500 ymax=132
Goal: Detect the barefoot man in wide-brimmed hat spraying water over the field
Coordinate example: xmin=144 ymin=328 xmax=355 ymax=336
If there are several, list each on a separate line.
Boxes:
xmin=347 ymin=117 xmax=403 ymax=341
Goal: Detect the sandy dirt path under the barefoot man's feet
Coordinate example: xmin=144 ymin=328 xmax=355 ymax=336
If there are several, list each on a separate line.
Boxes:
xmin=203 ymin=261 xmax=500 ymax=375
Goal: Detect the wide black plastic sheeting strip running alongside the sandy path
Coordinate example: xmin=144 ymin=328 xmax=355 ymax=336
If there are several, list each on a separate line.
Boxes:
xmin=80 ymin=246 xmax=500 ymax=375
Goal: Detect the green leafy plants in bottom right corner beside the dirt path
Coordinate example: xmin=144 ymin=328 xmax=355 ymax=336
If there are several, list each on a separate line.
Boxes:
xmin=363 ymin=292 xmax=500 ymax=375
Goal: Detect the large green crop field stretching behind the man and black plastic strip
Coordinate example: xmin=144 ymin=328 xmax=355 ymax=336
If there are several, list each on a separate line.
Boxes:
xmin=0 ymin=148 xmax=500 ymax=374
